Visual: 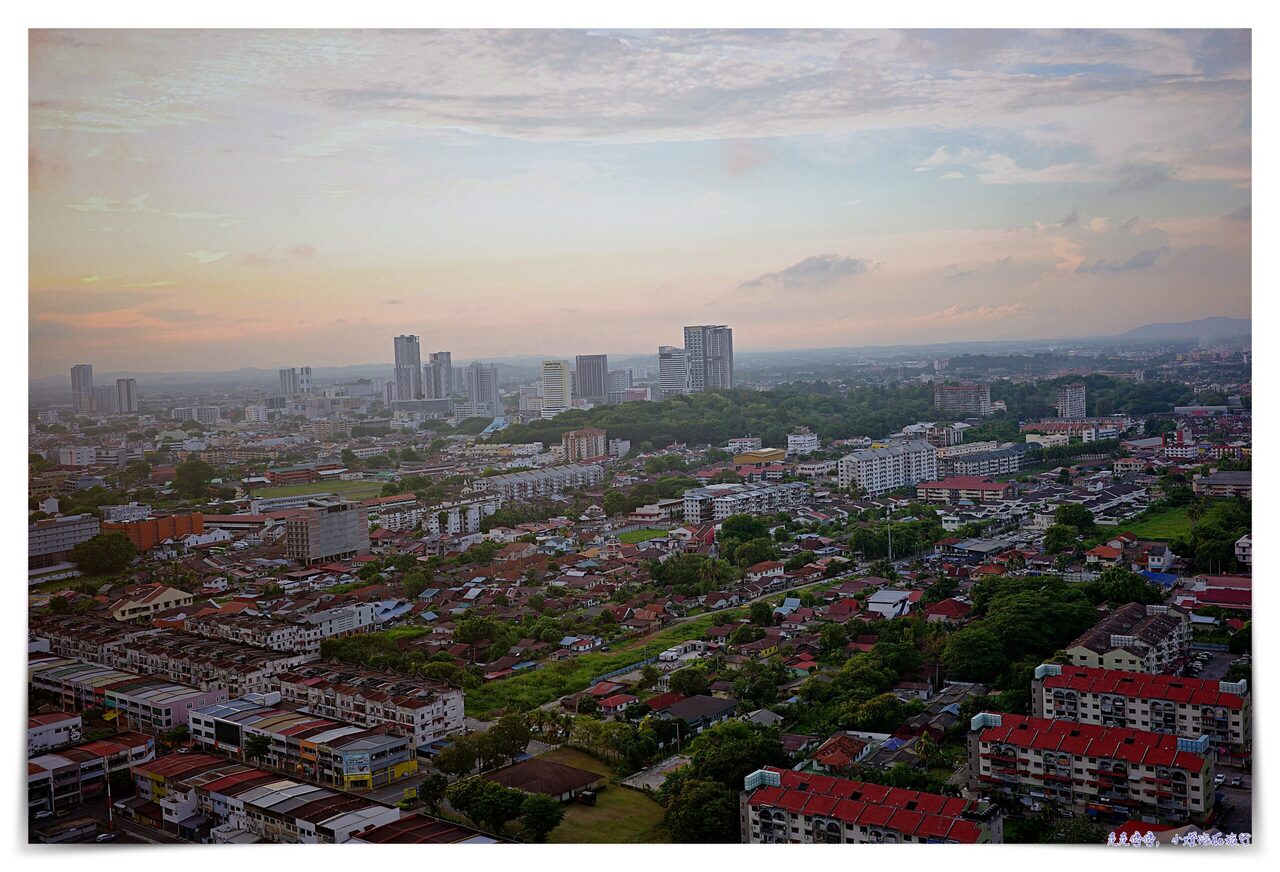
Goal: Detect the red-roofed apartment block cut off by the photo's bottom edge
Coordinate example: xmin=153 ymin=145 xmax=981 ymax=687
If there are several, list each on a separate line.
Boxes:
xmin=740 ymin=766 xmax=1004 ymax=845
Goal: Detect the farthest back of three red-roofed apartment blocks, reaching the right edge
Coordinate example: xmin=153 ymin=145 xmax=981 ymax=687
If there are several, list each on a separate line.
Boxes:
xmin=1032 ymin=663 xmax=1252 ymax=754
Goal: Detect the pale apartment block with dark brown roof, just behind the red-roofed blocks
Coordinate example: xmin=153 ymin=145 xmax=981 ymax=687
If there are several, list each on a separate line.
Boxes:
xmin=1066 ymin=603 xmax=1192 ymax=672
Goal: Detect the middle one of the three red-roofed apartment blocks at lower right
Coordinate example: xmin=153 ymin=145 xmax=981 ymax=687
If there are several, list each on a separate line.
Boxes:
xmin=969 ymin=712 xmax=1215 ymax=822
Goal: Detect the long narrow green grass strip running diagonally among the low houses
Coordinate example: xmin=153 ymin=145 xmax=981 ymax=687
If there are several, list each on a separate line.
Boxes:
xmin=465 ymin=611 xmax=737 ymax=717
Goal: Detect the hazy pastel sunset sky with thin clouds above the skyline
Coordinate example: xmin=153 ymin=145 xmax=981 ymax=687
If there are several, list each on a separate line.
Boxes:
xmin=29 ymin=29 xmax=1252 ymax=376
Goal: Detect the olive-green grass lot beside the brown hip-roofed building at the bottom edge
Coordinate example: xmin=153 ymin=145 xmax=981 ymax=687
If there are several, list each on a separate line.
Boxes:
xmin=543 ymin=748 xmax=671 ymax=844
